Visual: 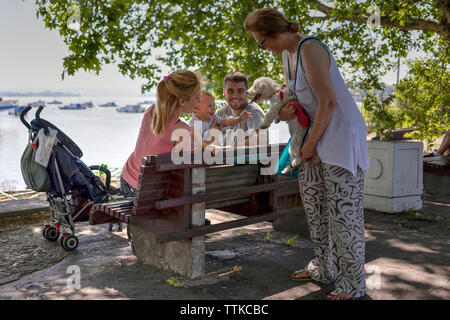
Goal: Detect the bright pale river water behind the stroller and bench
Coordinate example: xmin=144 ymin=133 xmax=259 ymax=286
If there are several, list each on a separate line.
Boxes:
xmin=0 ymin=97 xmax=289 ymax=191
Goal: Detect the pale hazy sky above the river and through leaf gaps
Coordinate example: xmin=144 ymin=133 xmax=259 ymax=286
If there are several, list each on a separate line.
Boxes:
xmin=0 ymin=0 xmax=428 ymax=96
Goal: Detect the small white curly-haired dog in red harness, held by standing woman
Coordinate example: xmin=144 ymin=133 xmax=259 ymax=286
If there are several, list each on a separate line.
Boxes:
xmin=247 ymin=77 xmax=310 ymax=174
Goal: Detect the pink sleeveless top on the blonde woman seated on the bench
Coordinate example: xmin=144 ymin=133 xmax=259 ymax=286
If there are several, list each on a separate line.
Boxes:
xmin=122 ymin=105 xmax=178 ymax=188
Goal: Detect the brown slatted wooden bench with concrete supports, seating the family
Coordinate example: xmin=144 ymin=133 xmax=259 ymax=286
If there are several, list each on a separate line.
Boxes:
xmin=90 ymin=144 xmax=303 ymax=278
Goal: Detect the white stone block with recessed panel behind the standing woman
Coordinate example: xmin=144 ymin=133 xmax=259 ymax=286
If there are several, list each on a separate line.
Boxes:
xmin=364 ymin=140 xmax=423 ymax=212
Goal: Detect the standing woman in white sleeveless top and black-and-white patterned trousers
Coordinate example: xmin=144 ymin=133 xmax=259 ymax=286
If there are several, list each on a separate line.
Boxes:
xmin=244 ymin=8 xmax=369 ymax=300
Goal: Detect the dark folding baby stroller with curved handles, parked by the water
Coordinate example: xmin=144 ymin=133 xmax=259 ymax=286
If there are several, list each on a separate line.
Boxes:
xmin=20 ymin=106 xmax=120 ymax=251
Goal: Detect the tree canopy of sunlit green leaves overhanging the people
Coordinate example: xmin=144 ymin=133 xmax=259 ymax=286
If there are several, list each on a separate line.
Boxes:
xmin=35 ymin=0 xmax=450 ymax=143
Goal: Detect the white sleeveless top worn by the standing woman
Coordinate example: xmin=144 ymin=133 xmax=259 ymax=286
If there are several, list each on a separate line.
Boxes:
xmin=282 ymin=36 xmax=369 ymax=175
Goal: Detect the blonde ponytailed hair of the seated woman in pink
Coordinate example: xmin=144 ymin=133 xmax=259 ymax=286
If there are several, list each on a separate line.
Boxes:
xmin=152 ymin=70 xmax=204 ymax=135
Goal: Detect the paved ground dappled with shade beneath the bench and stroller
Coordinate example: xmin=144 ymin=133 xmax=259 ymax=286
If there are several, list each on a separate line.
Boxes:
xmin=0 ymin=196 xmax=450 ymax=300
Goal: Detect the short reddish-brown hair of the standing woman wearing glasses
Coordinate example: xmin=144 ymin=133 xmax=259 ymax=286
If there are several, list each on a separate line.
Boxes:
xmin=244 ymin=8 xmax=299 ymax=37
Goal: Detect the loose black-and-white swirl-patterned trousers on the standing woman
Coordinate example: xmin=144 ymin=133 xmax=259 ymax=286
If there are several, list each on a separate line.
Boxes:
xmin=299 ymin=156 xmax=365 ymax=298
